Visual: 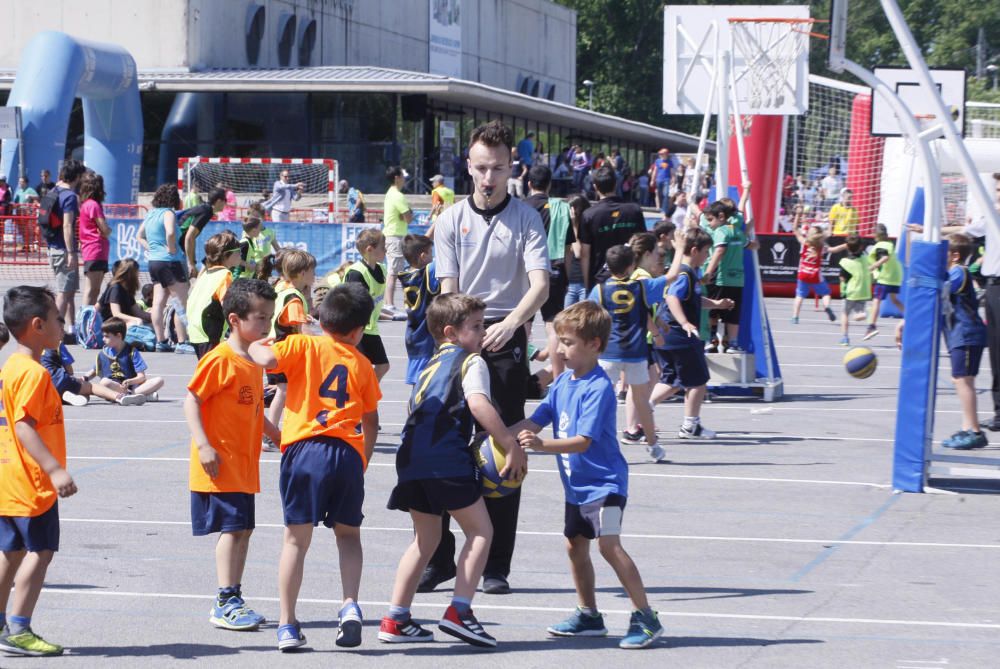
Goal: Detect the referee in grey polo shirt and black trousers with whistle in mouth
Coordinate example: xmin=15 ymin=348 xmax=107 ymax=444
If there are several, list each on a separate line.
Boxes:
xmin=418 ymin=121 xmax=549 ymax=594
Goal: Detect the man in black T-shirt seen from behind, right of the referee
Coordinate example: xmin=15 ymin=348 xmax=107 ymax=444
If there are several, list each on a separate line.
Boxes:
xmin=580 ymin=165 xmax=646 ymax=293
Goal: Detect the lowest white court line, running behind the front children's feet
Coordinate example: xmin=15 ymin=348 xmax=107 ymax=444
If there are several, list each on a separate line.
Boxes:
xmin=42 ymin=588 xmax=1000 ymax=630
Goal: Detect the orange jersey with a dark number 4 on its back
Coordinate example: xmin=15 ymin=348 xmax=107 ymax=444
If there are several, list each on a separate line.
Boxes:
xmin=267 ymin=335 xmax=382 ymax=466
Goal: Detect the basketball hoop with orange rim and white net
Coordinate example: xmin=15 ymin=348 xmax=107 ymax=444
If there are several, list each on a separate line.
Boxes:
xmin=729 ymin=18 xmax=828 ymax=113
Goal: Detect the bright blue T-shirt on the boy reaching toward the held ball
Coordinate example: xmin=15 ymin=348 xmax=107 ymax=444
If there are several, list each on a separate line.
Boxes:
xmin=531 ymin=366 xmax=628 ymax=505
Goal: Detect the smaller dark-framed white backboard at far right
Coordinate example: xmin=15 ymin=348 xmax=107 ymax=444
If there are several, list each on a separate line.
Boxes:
xmin=872 ymin=67 xmax=965 ymax=137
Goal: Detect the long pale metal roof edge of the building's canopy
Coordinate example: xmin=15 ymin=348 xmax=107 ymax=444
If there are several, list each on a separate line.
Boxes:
xmin=0 ymin=66 xmax=714 ymax=152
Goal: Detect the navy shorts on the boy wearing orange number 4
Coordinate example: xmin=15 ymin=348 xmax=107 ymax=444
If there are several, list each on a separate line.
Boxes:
xmin=278 ymin=436 xmax=365 ymax=527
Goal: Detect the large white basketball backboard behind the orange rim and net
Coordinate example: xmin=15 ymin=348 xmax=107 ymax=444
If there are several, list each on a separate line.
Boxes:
xmin=663 ymin=5 xmax=809 ymax=115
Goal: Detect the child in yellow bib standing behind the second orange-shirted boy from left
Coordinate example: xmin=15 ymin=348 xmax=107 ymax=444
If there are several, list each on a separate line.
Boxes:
xmin=187 ymin=230 xmax=240 ymax=360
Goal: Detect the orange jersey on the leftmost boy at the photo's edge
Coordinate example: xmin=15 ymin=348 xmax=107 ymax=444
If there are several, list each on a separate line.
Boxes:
xmin=0 ymin=353 xmax=66 ymax=518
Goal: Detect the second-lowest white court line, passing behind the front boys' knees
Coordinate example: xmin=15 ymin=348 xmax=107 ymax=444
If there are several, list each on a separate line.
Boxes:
xmin=60 ymin=518 xmax=1000 ymax=550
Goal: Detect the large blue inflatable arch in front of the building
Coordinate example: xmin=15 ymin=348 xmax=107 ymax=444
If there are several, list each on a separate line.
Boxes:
xmin=0 ymin=32 xmax=143 ymax=204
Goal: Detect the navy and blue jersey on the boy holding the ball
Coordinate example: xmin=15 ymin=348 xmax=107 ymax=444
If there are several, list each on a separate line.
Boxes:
xmin=396 ymin=344 xmax=479 ymax=482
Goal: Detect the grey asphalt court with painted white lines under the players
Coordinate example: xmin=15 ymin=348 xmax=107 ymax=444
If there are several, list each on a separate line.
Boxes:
xmin=0 ymin=299 xmax=1000 ymax=669
